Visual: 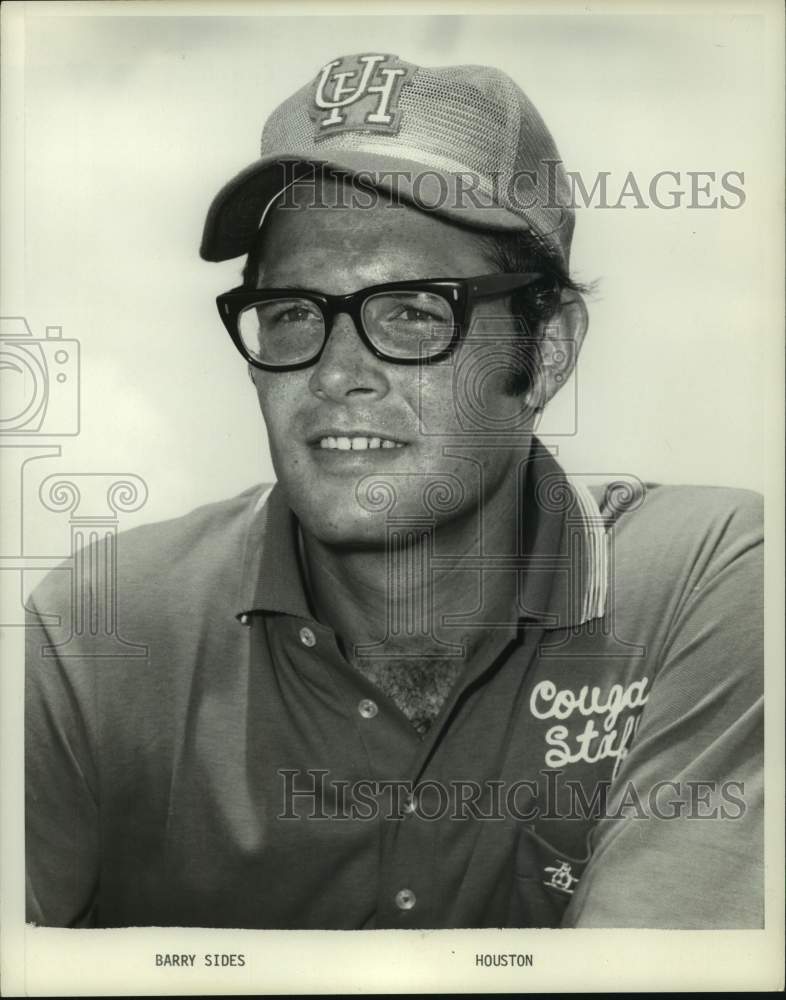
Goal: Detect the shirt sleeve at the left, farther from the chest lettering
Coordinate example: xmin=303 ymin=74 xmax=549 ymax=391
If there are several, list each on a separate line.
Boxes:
xmin=25 ymin=573 xmax=99 ymax=927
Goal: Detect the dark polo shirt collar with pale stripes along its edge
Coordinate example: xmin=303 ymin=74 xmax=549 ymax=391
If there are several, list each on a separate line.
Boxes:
xmin=236 ymin=441 xmax=608 ymax=629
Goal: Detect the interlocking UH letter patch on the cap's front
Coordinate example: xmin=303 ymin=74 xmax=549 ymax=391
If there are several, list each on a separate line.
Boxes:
xmin=309 ymin=55 xmax=416 ymax=142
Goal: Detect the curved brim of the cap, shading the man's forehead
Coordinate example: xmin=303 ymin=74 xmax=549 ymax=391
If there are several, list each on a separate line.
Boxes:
xmin=199 ymin=150 xmax=546 ymax=261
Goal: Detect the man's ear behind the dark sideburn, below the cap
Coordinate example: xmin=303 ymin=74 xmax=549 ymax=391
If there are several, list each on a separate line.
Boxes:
xmin=527 ymin=288 xmax=589 ymax=410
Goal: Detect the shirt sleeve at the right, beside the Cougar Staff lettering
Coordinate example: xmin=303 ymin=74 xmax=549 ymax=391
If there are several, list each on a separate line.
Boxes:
xmin=563 ymin=492 xmax=764 ymax=929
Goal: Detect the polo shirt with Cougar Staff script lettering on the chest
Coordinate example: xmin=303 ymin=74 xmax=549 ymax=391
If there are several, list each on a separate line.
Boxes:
xmin=26 ymin=448 xmax=763 ymax=928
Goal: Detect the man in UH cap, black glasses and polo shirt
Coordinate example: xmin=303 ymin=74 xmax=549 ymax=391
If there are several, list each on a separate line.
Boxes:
xmin=27 ymin=53 xmax=763 ymax=929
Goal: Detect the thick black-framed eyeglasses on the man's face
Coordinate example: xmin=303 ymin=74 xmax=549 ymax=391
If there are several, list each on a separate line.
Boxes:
xmin=216 ymin=273 xmax=543 ymax=371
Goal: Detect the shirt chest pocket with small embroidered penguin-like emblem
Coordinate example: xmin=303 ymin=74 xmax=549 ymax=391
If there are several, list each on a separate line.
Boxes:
xmin=508 ymin=826 xmax=592 ymax=927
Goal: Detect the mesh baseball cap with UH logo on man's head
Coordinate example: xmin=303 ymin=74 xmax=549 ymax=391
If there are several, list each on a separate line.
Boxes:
xmin=200 ymin=53 xmax=574 ymax=267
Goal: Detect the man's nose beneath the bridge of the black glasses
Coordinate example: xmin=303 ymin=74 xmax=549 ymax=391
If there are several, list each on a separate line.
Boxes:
xmin=309 ymin=313 xmax=390 ymax=402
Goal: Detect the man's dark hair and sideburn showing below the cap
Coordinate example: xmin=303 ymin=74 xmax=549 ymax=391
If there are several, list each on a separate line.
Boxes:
xmin=243 ymin=202 xmax=588 ymax=394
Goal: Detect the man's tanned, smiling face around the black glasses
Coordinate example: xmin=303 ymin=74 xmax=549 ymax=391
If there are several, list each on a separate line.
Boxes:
xmin=252 ymin=180 xmax=540 ymax=547
